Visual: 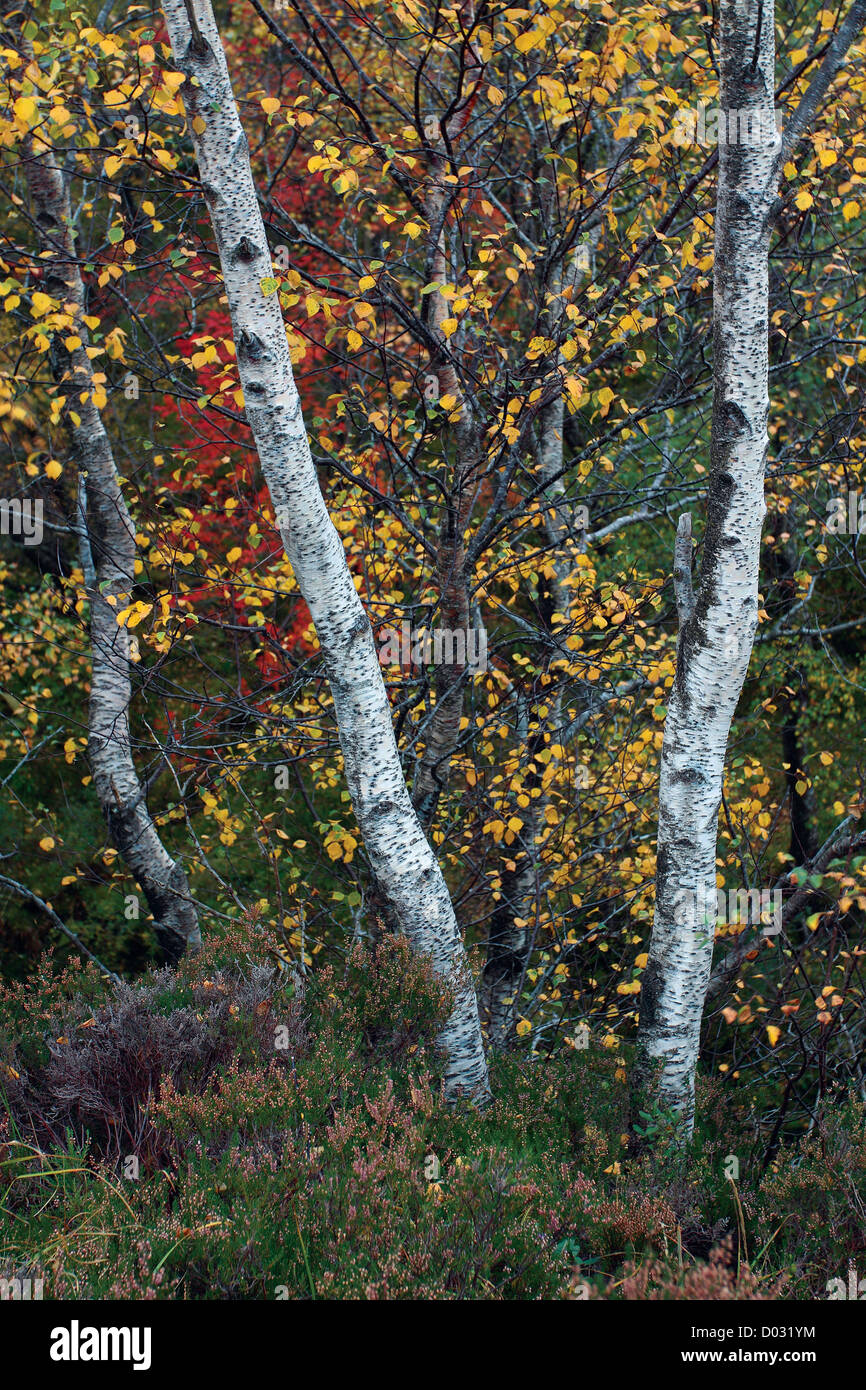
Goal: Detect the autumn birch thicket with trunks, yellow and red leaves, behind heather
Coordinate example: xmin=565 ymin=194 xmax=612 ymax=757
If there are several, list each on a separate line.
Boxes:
xmin=0 ymin=0 xmax=866 ymax=1155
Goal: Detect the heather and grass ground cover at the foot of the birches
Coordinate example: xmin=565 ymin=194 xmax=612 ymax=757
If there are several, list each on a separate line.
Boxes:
xmin=0 ymin=919 xmax=866 ymax=1300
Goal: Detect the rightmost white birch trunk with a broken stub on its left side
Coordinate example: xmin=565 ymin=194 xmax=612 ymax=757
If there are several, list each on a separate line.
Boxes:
xmin=634 ymin=0 xmax=780 ymax=1136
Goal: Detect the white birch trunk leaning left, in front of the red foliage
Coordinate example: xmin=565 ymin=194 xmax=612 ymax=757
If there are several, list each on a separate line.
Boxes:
xmin=163 ymin=0 xmax=489 ymax=1104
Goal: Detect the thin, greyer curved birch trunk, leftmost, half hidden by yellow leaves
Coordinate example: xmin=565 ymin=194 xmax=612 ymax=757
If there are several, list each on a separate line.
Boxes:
xmin=24 ymin=136 xmax=202 ymax=963
